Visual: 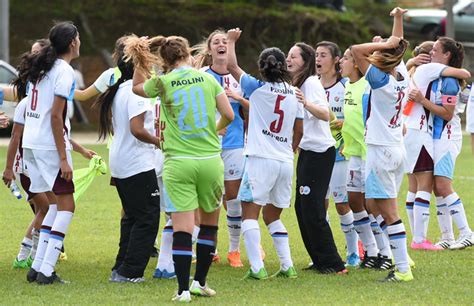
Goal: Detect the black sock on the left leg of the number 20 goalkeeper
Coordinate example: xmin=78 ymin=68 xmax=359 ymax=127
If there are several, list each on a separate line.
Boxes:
xmin=173 ymin=232 xmax=193 ymax=294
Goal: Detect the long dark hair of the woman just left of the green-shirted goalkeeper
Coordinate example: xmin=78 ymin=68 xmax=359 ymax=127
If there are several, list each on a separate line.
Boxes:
xmin=92 ymin=57 xmax=133 ymax=139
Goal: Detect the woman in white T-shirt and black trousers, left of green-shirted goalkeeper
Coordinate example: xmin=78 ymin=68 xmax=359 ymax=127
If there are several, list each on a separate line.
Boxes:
xmin=94 ymin=44 xmax=160 ymax=283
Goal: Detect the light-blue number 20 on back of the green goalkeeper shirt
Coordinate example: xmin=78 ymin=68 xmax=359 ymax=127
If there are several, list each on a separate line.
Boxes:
xmin=174 ymin=86 xmax=209 ymax=131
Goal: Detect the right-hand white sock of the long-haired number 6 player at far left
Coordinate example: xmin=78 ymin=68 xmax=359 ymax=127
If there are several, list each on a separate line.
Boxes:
xmin=40 ymin=210 xmax=74 ymax=276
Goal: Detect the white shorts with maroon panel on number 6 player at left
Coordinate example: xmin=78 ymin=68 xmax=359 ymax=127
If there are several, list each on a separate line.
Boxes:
xmin=23 ymin=148 xmax=74 ymax=194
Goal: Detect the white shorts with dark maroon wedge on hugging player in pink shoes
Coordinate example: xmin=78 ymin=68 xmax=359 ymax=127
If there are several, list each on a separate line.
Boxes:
xmin=403 ymin=129 xmax=434 ymax=173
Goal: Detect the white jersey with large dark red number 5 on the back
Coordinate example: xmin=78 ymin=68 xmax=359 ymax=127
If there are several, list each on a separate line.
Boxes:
xmin=240 ymin=73 xmax=303 ymax=163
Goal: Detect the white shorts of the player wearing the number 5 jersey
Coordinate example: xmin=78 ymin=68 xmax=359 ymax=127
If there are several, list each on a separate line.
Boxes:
xmin=237 ymin=156 xmax=293 ymax=208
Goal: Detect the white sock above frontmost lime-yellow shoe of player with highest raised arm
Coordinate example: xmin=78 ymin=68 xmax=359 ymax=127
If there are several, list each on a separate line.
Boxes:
xmin=387 ymin=220 xmax=410 ymax=273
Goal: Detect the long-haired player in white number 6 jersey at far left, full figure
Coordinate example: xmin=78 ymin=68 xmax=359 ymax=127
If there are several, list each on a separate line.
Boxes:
xmin=23 ymin=22 xmax=81 ymax=284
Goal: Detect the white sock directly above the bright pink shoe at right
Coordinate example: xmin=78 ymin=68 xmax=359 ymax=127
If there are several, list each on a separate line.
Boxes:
xmin=413 ymin=191 xmax=431 ymax=243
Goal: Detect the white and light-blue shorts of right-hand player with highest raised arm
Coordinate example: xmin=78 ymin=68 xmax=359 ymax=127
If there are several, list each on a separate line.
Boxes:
xmin=365 ymin=145 xmax=405 ymax=199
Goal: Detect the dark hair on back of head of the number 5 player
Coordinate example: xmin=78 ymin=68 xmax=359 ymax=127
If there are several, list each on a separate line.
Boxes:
xmin=258 ymin=47 xmax=291 ymax=84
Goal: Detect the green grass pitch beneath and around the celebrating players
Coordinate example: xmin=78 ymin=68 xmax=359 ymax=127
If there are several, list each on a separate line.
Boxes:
xmin=0 ymin=138 xmax=474 ymax=305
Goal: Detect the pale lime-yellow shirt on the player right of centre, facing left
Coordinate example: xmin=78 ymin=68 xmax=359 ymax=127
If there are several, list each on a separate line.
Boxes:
xmin=342 ymin=77 xmax=370 ymax=160
